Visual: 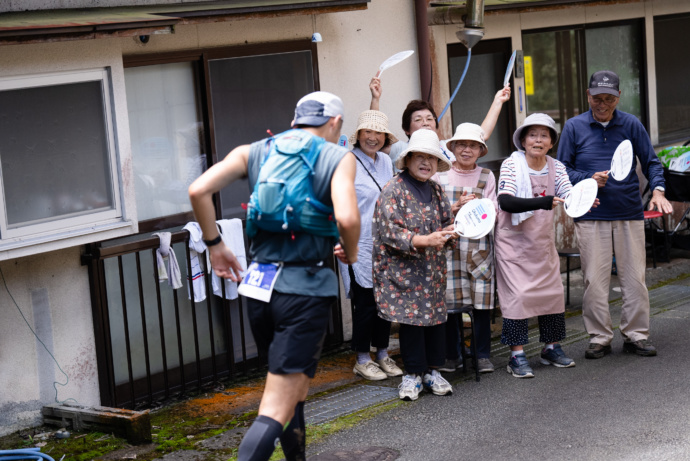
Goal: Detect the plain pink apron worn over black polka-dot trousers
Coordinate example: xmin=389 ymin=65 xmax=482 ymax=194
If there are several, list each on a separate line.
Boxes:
xmin=495 ymin=156 xmax=565 ymax=320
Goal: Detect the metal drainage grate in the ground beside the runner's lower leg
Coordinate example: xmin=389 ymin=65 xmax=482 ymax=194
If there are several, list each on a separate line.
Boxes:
xmin=304 ymin=385 xmax=398 ymax=424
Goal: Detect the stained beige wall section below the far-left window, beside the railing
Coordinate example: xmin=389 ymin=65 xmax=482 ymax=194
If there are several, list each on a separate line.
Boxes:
xmin=0 ymin=248 xmax=100 ymax=435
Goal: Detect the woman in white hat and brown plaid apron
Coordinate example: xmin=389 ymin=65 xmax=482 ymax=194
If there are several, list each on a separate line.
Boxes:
xmin=437 ymin=123 xmax=498 ymax=373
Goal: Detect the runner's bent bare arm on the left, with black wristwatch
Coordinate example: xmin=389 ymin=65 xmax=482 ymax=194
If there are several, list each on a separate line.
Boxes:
xmin=189 ymin=145 xmax=249 ymax=282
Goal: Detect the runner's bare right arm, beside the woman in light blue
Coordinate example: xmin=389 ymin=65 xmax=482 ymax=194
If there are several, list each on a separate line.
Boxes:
xmin=331 ymin=152 xmax=361 ymax=263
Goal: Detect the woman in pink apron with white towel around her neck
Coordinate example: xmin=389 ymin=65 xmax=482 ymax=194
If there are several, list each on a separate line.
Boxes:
xmin=495 ymin=114 xmax=575 ymax=378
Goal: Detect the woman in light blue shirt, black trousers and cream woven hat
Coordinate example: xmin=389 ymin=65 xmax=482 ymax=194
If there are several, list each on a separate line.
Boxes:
xmin=339 ymin=110 xmax=402 ymax=381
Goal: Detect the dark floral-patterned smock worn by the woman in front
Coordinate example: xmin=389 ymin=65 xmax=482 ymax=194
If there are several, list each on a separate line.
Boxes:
xmin=372 ymin=176 xmax=455 ymax=326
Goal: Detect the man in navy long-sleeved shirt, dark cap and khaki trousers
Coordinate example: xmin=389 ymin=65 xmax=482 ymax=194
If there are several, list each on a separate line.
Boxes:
xmin=558 ymin=70 xmax=673 ymax=359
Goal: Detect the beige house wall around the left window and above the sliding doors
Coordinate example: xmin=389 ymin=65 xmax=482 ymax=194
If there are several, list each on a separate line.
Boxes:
xmin=0 ymin=0 xmax=419 ymax=435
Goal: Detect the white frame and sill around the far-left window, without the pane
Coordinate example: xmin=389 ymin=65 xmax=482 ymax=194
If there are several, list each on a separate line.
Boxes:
xmin=0 ymin=67 xmax=123 ymax=244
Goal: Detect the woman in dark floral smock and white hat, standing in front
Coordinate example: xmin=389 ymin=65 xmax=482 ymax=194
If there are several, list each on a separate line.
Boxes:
xmin=372 ymin=129 xmax=457 ymax=400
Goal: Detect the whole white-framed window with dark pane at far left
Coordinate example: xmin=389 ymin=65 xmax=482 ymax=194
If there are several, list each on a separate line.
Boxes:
xmin=0 ymin=69 xmax=122 ymax=243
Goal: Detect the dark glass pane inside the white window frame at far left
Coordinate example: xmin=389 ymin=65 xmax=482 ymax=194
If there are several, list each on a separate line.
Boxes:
xmin=0 ymin=81 xmax=114 ymax=229
